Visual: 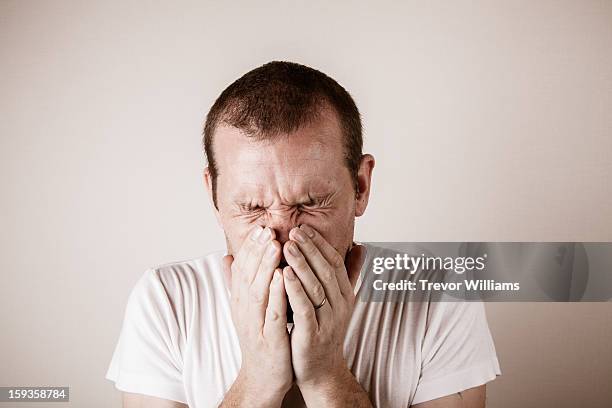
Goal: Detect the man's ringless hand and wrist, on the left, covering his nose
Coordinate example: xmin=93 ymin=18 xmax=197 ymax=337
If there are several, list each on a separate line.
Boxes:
xmin=221 ymin=227 xmax=293 ymax=407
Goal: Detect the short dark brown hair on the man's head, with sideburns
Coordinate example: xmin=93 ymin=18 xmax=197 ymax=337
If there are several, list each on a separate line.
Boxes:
xmin=203 ymin=61 xmax=363 ymax=207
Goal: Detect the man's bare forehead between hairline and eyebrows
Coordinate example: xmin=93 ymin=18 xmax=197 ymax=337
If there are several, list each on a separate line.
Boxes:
xmin=214 ymin=107 xmax=348 ymax=198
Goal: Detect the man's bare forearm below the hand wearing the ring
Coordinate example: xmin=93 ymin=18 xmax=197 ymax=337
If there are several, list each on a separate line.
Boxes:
xmin=300 ymin=369 xmax=372 ymax=408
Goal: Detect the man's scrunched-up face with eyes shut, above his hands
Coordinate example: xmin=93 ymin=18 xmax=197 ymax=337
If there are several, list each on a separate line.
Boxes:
xmin=207 ymin=110 xmax=371 ymax=262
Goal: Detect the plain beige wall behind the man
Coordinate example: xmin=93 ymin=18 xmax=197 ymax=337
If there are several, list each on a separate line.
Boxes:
xmin=0 ymin=0 xmax=612 ymax=407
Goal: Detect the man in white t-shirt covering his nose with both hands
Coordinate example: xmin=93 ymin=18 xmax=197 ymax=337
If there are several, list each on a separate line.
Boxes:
xmin=107 ymin=62 xmax=499 ymax=408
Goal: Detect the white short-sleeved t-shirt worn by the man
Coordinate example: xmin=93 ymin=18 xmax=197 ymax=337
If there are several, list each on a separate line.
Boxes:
xmin=106 ymin=245 xmax=501 ymax=408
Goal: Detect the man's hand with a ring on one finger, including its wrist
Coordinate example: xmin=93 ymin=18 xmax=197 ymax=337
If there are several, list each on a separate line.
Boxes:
xmin=283 ymin=225 xmax=371 ymax=407
